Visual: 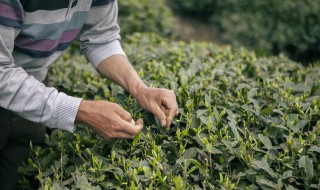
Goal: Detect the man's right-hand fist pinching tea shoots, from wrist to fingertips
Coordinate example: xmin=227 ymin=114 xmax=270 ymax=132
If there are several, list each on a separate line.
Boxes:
xmin=136 ymin=86 xmax=179 ymax=127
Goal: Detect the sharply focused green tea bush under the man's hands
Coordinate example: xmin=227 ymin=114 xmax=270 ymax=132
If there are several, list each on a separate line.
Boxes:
xmin=20 ymin=34 xmax=320 ymax=189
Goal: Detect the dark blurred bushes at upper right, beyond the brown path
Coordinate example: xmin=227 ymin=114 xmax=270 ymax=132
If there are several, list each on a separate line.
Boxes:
xmin=168 ymin=0 xmax=320 ymax=63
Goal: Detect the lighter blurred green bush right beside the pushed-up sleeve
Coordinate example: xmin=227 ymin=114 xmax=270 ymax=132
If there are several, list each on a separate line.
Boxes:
xmin=118 ymin=0 xmax=174 ymax=36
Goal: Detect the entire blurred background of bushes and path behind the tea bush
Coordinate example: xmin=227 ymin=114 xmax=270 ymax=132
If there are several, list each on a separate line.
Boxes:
xmin=118 ymin=0 xmax=320 ymax=64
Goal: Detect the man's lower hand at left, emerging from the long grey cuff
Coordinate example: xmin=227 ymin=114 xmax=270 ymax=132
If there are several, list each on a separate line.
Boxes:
xmin=76 ymin=100 xmax=143 ymax=139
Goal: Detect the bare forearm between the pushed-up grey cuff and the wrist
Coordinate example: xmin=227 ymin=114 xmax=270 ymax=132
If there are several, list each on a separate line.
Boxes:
xmin=97 ymin=55 xmax=146 ymax=98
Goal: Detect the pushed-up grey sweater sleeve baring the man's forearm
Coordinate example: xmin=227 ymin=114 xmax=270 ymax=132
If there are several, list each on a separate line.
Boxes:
xmin=80 ymin=0 xmax=125 ymax=68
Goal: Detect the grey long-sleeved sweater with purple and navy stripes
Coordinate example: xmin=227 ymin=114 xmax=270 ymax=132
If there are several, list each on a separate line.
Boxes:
xmin=0 ymin=0 xmax=124 ymax=132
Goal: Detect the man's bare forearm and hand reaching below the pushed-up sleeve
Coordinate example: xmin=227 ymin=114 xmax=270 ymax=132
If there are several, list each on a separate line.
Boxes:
xmin=97 ymin=55 xmax=179 ymax=127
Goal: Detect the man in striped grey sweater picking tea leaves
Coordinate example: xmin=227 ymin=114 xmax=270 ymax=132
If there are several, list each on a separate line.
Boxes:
xmin=0 ymin=0 xmax=178 ymax=190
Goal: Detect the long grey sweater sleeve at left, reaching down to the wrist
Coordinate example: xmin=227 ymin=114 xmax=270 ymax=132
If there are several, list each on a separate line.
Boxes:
xmin=0 ymin=0 xmax=81 ymax=132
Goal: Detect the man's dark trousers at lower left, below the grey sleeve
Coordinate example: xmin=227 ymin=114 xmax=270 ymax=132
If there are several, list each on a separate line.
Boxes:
xmin=0 ymin=78 xmax=48 ymax=190
